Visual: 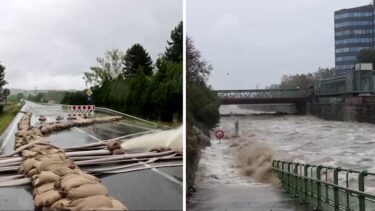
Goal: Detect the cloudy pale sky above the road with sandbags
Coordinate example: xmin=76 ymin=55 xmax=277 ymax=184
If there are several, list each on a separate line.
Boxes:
xmin=0 ymin=0 xmax=182 ymax=89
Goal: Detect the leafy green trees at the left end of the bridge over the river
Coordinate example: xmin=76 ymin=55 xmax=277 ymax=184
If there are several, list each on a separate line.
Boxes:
xmin=186 ymin=38 xmax=220 ymax=129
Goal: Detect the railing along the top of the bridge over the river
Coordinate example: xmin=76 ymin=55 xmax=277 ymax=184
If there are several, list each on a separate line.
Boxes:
xmin=215 ymin=89 xmax=308 ymax=98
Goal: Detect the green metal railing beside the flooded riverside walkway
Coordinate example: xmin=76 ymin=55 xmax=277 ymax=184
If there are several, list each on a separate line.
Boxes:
xmin=272 ymin=160 xmax=375 ymax=211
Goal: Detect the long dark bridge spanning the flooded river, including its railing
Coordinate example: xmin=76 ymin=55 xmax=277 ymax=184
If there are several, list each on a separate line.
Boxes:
xmin=215 ymin=89 xmax=310 ymax=105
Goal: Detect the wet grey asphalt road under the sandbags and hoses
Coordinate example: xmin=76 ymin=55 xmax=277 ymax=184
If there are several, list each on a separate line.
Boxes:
xmin=0 ymin=103 xmax=183 ymax=210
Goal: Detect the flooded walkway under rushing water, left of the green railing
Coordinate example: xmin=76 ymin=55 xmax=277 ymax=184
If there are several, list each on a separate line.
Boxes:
xmin=187 ymin=135 xmax=310 ymax=211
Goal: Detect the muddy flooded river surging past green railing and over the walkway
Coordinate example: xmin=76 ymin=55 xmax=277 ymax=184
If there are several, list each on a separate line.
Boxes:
xmin=190 ymin=105 xmax=375 ymax=210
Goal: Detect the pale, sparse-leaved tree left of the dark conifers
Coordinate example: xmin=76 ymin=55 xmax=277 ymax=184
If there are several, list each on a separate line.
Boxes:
xmin=83 ymin=49 xmax=124 ymax=86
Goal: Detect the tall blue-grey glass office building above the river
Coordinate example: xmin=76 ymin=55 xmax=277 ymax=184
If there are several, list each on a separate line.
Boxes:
xmin=335 ymin=0 xmax=375 ymax=75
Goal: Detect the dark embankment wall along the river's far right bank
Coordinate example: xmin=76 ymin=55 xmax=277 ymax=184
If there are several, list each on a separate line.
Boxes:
xmin=307 ymin=96 xmax=375 ymax=123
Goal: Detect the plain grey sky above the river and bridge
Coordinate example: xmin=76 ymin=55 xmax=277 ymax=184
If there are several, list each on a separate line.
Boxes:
xmin=187 ymin=0 xmax=371 ymax=89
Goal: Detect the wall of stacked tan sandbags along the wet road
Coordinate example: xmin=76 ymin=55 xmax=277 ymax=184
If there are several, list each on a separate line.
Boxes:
xmin=15 ymin=113 xmax=127 ymax=210
